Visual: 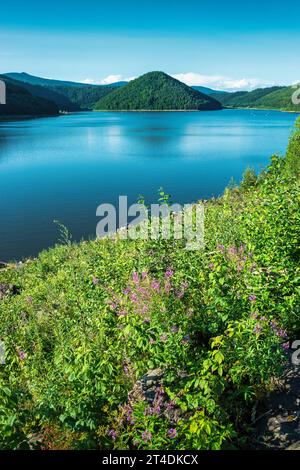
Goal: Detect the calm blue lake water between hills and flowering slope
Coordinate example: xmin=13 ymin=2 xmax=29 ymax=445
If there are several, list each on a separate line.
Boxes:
xmin=0 ymin=110 xmax=296 ymax=261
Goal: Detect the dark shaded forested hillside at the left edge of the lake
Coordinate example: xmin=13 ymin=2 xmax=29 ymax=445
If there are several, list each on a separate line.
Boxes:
xmin=0 ymin=75 xmax=59 ymax=116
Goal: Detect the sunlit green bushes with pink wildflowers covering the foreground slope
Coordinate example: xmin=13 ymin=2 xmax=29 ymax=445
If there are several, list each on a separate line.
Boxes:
xmin=0 ymin=121 xmax=300 ymax=449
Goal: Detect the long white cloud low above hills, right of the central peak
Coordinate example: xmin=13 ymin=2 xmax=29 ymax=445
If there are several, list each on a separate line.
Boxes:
xmin=172 ymin=72 xmax=273 ymax=91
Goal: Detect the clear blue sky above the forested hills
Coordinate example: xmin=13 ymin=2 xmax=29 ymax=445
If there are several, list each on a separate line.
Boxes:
xmin=0 ymin=0 xmax=300 ymax=90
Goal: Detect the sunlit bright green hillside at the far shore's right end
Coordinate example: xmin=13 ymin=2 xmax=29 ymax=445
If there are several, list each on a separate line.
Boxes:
xmin=211 ymin=86 xmax=300 ymax=111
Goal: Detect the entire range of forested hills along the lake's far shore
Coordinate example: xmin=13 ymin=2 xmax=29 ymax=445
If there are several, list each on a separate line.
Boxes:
xmin=0 ymin=72 xmax=300 ymax=115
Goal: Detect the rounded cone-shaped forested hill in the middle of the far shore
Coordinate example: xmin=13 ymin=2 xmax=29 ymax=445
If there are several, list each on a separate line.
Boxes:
xmin=96 ymin=72 xmax=221 ymax=111
